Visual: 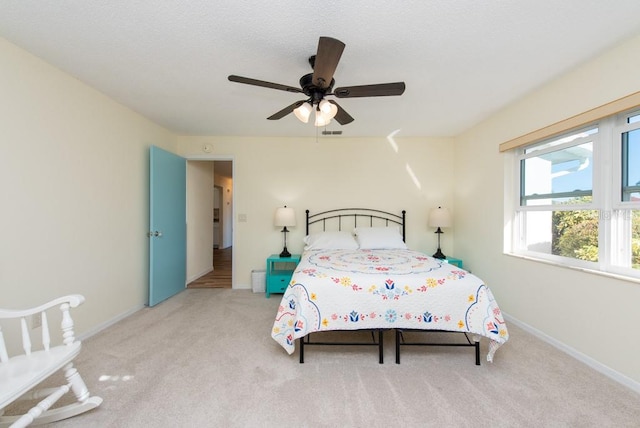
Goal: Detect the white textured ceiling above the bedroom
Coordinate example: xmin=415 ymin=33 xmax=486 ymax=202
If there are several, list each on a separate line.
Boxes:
xmin=0 ymin=0 xmax=640 ymax=137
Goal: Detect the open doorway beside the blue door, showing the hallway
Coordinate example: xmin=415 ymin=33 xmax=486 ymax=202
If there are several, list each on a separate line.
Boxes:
xmin=187 ymin=160 xmax=233 ymax=288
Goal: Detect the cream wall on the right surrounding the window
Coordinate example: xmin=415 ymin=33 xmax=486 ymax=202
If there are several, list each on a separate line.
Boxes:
xmin=455 ymin=37 xmax=640 ymax=390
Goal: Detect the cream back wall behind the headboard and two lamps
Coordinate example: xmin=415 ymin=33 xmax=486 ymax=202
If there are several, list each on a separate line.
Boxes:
xmin=179 ymin=136 xmax=455 ymax=288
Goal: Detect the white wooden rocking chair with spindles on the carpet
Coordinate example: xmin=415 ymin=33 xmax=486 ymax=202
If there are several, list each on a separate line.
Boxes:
xmin=0 ymin=294 xmax=102 ymax=428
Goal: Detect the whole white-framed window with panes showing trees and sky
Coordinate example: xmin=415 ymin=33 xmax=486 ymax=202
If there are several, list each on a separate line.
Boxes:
xmin=510 ymin=111 xmax=640 ymax=277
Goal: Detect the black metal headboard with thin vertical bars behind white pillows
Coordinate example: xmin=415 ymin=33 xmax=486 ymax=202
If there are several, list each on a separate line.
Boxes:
xmin=306 ymin=208 xmax=407 ymax=241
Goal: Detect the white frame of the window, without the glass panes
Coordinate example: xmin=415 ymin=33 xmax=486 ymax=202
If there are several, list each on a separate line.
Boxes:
xmin=505 ymin=109 xmax=640 ymax=279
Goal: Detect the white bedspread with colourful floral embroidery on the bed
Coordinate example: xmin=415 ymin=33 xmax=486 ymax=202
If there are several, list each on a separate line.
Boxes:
xmin=271 ymin=250 xmax=509 ymax=361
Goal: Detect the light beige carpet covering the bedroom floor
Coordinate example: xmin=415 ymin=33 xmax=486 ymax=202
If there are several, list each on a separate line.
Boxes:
xmin=6 ymin=289 xmax=640 ymax=428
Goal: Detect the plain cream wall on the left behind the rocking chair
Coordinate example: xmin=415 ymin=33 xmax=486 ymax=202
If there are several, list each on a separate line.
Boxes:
xmin=0 ymin=39 xmax=175 ymax=342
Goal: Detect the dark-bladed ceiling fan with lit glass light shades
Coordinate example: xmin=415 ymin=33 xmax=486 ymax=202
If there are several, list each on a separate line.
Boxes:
xmin=229 ymin=37 xmax=405 ymax=126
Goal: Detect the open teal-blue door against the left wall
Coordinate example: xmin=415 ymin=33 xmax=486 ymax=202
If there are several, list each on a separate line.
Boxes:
xmin=149 ymin=146 xmax=187 ymax=306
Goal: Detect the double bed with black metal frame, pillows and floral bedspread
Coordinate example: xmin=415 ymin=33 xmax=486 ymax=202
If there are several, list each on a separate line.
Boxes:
xmin=272 ymin=208 xmax=508 ymax=365
